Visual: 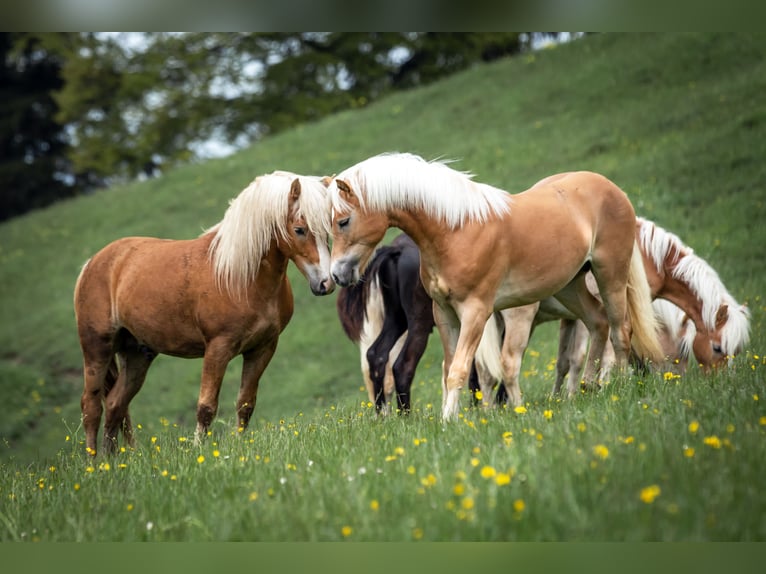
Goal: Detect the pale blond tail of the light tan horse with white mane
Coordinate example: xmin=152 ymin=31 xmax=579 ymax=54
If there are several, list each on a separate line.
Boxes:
xmin=627 ymin=241 xmax=664 ymax=363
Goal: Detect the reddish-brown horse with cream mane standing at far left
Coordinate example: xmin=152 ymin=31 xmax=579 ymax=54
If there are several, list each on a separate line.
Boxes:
xmin=74 ymin=172 xmax=335 ymax=455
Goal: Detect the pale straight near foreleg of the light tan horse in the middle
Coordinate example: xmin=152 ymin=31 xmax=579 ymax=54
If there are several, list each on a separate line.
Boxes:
xmin=442 ymin=300 xmax=492 ymax=420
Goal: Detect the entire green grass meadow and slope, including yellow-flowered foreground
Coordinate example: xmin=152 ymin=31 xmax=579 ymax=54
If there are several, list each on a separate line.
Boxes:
xmin=0 ymin=34 xmax=766 ymax=541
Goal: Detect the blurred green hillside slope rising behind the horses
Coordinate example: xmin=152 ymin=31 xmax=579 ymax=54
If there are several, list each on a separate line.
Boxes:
xmin=0 ymin=30 xmax=766 ymax=463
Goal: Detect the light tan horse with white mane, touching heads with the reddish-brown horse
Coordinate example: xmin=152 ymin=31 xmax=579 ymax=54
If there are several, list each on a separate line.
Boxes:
xmin=329 ymin=154 xmax=661 ymax=420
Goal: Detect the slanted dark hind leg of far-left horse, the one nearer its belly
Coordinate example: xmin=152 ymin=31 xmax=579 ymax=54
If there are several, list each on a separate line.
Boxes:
xmin=104 ymin=346 xmax=157 ymax=460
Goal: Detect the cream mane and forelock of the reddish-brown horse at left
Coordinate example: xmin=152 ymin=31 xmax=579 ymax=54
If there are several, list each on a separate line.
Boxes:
xmin=205 ymin=171 xmax=330 ymax=292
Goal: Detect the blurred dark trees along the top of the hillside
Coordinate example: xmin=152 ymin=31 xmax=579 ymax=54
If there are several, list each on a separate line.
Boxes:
xmin=0 ymin=32 xmax=555 ymax=221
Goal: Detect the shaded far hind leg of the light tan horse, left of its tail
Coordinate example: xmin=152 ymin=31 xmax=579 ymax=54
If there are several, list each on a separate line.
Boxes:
xmin=554 ymin=273 xmax=609 ymax=397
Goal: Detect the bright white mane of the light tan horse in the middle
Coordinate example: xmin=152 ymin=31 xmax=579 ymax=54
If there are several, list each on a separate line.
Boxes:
xmin=329 ymin=153 xmax=510 ymax=229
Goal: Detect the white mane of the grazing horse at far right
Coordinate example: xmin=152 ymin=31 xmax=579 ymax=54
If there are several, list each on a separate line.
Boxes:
xmin=636 ymin=217 xmax=750 ymax=355
